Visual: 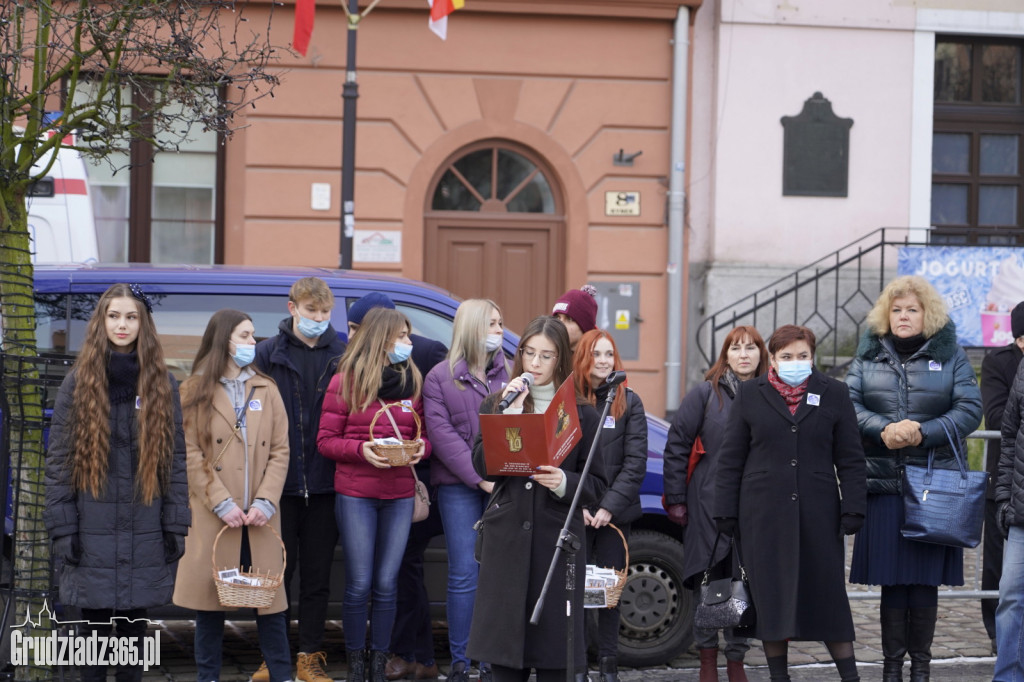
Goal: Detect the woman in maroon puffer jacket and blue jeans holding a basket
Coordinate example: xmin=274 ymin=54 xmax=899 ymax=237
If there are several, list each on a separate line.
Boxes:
xmin=316 ymin=308 xmax=430 ymax=682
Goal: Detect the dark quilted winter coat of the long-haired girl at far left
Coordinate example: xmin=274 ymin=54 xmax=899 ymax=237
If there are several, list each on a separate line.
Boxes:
xmin=43 ymin=370 xmax=191 ymax=610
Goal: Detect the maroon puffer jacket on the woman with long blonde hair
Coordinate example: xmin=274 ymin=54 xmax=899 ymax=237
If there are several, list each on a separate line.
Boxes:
xmin=316 ymin=375 xmax=430 ymax=500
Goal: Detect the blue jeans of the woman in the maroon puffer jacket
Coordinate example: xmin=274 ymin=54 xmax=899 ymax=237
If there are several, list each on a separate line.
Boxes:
xmin=334 ymin=494 xmax=413 ymax=651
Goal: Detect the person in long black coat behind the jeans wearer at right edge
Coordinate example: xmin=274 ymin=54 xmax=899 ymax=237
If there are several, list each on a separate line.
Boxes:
xmin=981 ymin=302 xmax=1024 ymax=653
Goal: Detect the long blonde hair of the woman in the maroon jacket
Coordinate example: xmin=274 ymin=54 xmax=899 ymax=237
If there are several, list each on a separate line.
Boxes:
xmin=338 ymin=308 xmax=423 ymax=410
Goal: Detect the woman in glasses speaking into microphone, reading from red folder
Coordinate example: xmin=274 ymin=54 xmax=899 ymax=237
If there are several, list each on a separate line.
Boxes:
xmin=466 ymin=315 xmax=607 ymax=682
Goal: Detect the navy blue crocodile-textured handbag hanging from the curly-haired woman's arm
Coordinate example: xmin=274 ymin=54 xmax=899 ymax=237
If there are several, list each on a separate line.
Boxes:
xmin=900 ymin=417 xmax=988 ymax=547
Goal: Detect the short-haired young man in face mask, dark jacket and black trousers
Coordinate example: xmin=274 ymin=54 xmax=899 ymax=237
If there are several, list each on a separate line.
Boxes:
xmin=253 ymin=278 xmax=345 ymax=682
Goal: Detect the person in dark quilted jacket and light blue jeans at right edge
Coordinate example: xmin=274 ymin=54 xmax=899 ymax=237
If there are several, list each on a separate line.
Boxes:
xmin=992 ymin=346 xmax=1024 ymax=682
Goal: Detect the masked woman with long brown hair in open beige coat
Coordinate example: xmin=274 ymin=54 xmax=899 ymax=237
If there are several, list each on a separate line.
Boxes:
xmin=174 ymin=309 xmax=292 ymax=682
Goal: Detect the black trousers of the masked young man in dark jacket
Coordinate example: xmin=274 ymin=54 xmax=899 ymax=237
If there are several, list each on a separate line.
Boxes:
xmin=281 ymin=493 xmax=338 ymax=653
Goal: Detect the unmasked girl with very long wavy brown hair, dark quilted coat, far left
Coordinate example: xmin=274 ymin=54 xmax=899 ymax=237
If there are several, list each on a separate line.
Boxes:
xmin=43 ymin=284 xmax=190 ymax=681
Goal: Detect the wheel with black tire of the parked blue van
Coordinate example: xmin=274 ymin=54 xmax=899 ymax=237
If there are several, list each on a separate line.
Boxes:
xmin=618 ymin=530 xmax=693 ymax=668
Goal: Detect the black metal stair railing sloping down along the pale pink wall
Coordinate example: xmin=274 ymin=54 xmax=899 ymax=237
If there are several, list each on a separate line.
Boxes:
xmin=696 ymin=227 xmax=930 ymax=376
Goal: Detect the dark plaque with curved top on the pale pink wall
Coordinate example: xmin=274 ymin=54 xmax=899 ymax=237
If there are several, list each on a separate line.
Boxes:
xmin=782 ymin=92 xmax=853 ymax=197
